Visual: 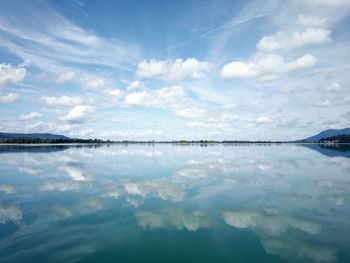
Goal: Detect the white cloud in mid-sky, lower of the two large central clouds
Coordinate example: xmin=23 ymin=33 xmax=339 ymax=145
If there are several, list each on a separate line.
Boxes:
xmin=124 ymin=86 xmax=185 ymax=107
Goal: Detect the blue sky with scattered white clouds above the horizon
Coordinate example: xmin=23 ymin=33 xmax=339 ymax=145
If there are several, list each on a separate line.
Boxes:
xmin=0 ymin=0 xmax=350 ymax=140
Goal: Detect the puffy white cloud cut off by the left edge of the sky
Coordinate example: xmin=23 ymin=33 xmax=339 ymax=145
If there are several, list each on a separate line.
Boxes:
xmin=0 ymin=64 xmax=27 ymax=87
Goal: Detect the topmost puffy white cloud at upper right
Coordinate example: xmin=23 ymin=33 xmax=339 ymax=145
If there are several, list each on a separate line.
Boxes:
xmin=256 ymin=28 xmax=331 ymax=52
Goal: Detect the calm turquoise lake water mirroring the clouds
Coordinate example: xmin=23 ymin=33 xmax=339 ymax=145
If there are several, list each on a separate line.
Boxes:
xmin=0 ymin=144 xmax=350 ymax=262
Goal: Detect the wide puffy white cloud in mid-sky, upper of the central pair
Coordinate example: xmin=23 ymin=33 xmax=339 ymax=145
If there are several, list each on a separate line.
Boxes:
xmin=136 ymin=58 xmax=210 ymax=81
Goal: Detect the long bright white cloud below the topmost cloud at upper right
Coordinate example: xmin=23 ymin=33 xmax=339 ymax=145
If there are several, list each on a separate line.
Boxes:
xmin=221 ymin=54 xmax=316 ymax=80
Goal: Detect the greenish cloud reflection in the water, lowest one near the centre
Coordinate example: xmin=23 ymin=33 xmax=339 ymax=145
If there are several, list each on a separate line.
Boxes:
xmin=136 ymin=207 xmax=210 ymax=231
